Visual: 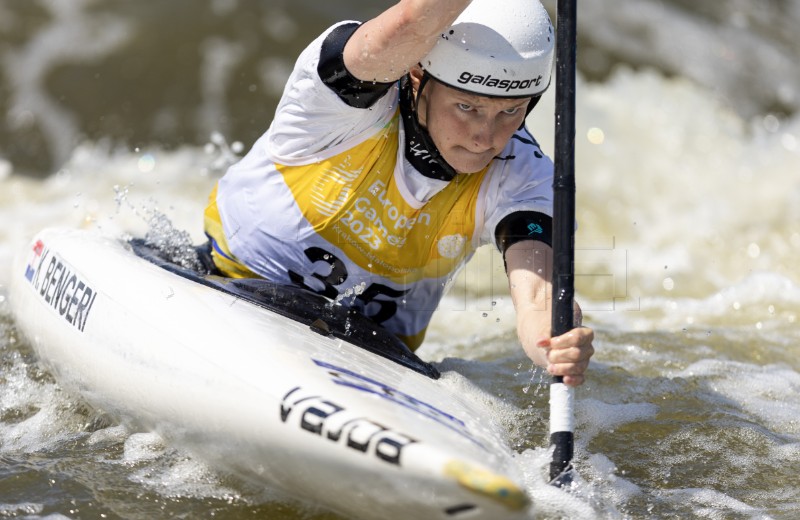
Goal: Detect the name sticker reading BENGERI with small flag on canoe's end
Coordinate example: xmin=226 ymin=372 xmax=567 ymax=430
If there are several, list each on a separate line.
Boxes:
xmin=25 ymin=240 xmax=97 ymax=332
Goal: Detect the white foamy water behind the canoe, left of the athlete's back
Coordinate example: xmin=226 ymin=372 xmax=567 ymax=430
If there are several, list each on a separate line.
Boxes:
xmin=0 ymin=134 xmax=241 ymax=285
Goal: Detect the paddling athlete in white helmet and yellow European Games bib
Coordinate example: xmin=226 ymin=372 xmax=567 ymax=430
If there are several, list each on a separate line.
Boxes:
xmin=205 ymin=0 xmax=594 ymax=386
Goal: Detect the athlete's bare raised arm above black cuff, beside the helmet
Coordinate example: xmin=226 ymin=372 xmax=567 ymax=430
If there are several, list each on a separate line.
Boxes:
xmin=344 ymin=0 xmax=471 ymax=83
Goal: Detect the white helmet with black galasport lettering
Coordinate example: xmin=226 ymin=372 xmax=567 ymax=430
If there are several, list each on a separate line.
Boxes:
xmin=421 ymin=0 xmax=555 ymax=98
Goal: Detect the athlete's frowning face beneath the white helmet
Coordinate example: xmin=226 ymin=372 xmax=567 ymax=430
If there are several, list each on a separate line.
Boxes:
xmin=412 ymin=68 xmax=530 ymax=173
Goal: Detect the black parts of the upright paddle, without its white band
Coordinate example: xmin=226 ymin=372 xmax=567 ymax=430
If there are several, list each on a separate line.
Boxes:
xmin=550 ymin=0 xmax=577 ymax=480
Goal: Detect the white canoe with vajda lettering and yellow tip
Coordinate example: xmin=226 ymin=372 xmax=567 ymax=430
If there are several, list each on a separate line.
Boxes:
xmin=11 ymin=229 xmax=532 ymax=519
